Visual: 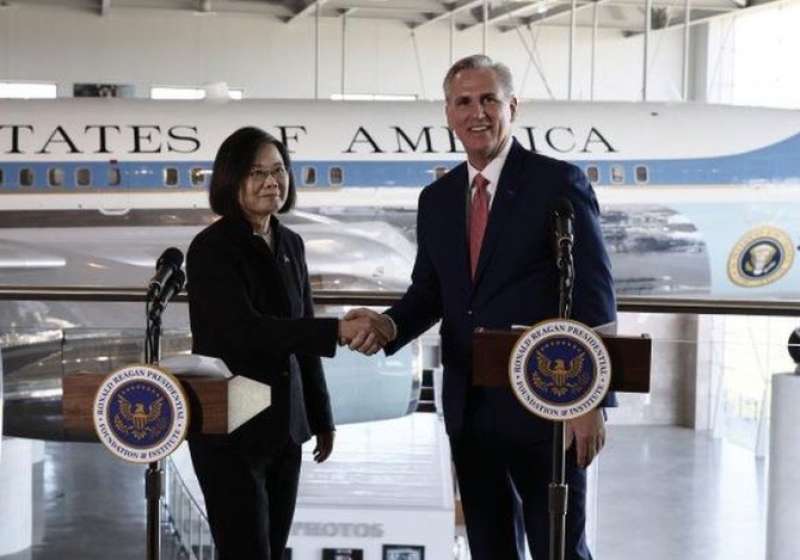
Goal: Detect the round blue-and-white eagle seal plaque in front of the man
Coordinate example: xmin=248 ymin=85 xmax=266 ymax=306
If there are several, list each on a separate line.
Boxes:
xmin=508 ymin=319 xmax=611 ymax=420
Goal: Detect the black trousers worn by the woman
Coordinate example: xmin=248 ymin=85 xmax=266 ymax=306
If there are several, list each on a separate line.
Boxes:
xmin=189 ymin=440 xmax=301 ymax=560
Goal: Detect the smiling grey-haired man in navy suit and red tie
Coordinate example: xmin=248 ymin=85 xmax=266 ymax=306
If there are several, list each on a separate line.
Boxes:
xmin=350 ymin=55 xmax=616 ymax=560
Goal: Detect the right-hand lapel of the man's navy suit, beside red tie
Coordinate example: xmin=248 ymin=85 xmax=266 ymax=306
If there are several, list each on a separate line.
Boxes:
xmin=465 ymin=137 xmax=524 ymax=294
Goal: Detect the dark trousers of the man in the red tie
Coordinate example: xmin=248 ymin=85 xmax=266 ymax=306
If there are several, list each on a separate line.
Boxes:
xmin=450 ymin=396 xmax=592 ymax=560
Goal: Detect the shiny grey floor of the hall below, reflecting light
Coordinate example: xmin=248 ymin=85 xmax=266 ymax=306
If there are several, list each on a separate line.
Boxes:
xmin=0 ymin=426 xmax=766 ymax=560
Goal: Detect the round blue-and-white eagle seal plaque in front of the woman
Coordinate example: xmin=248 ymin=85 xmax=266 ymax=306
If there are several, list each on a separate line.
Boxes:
xmin=92 ymin=365 xmax=189 ymax=463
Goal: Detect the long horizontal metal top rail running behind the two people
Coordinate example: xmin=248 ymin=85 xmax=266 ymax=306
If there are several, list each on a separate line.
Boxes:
xmin=0 ymin=286 xmax=800 ymax=317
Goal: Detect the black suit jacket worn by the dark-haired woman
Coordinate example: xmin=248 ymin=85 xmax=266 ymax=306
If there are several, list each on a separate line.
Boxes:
xmin=186 ymin=217 xmax=338 ymax=451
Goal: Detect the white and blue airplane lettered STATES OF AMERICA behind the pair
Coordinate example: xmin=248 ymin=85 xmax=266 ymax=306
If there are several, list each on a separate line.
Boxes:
xmin=0 ymin=99 xmax=800 ymax=442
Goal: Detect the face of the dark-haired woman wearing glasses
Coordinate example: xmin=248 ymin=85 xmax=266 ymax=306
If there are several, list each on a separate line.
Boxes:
xmin=239 ymin=144 xmax=289 ymax=226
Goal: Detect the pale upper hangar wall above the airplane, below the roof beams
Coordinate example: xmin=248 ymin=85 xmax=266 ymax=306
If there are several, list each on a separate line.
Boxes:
xmin=0 ymin=4 xmax=682 ymax=100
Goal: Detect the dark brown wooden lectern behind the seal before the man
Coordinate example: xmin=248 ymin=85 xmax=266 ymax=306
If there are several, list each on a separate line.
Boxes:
xmin=472 ymin=329 xmax=653 ymax=393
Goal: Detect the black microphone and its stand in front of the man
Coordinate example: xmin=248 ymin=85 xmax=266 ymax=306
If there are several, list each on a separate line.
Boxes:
xmin=548 ymin=232 xmax=575 ymax=560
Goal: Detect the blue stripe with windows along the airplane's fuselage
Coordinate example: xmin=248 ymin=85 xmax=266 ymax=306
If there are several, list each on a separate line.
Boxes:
xmin=0 ymin=134 xmax=800 ymax=193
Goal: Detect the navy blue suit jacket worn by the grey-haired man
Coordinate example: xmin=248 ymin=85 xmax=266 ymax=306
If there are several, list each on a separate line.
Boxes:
xmin=386 ymin=140 xmax=616 ymax=439
